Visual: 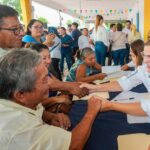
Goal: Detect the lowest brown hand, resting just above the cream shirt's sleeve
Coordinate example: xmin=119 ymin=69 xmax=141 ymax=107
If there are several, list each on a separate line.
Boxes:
xmin=51 ymin=113 xmax=71 ymax=130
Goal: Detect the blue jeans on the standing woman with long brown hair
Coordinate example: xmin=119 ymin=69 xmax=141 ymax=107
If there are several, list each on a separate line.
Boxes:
xmin=95 ymin=41 xmax=107 ymax=66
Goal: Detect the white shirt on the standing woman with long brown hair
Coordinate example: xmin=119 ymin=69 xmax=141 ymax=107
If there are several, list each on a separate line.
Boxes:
xmin=91 ymin=26 xmax=109 ymax=46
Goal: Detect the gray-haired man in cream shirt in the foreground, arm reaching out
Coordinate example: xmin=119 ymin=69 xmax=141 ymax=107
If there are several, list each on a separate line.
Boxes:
xmin=0 ymin=49 xmax=101 ymax=150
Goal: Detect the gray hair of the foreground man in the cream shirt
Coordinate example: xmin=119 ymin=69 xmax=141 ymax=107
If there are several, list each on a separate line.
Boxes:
xmin=0 ymin=48 xmax=41 ymax=99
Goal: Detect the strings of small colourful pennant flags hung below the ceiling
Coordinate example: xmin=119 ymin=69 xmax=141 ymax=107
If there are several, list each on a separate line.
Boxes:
xmin=60 ymin=8 xmax=132 ymax=19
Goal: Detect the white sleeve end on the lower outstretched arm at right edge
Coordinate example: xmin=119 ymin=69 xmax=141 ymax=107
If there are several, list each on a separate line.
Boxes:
xmin=141 ymin=99 xmax=150 ymax=117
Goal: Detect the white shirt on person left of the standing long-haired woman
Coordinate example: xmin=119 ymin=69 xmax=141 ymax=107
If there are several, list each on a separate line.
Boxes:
xmin=78 ymin=35 xmax=91 ymax=49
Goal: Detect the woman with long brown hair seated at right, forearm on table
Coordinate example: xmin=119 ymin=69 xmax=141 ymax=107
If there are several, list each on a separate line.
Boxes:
xmin=121 ymin=39 xmax=144 ymax=70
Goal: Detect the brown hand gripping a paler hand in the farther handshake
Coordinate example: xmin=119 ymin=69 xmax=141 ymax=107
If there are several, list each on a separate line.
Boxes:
xmin=69 ymin=82 xmax=89 ymax=98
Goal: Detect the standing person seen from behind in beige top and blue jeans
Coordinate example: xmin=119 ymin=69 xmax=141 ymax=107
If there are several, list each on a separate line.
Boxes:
xmin=110 ymin=23 xmax=127 ymax=65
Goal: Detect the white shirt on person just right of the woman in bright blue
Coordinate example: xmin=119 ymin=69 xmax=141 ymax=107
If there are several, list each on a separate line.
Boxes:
xmin=49 ymin=36 xmax=61 ymax=59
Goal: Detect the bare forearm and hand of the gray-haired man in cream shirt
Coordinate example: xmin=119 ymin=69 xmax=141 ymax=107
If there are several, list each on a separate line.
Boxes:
xmin=69 ymin=98 xmax=101 ymax=150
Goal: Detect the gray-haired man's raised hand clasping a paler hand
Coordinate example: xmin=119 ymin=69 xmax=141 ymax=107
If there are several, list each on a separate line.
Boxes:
xmin=88 ymin=96 xmax=102 ymax=114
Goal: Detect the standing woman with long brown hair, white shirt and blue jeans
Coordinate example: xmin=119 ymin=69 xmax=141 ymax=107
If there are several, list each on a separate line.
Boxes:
xmin=91 ymin=15 xmax=108 ymax=66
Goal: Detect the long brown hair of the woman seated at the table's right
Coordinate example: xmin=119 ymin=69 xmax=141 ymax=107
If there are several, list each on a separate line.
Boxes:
xmin=131 ymin=39 xmax=144 ymax=65
